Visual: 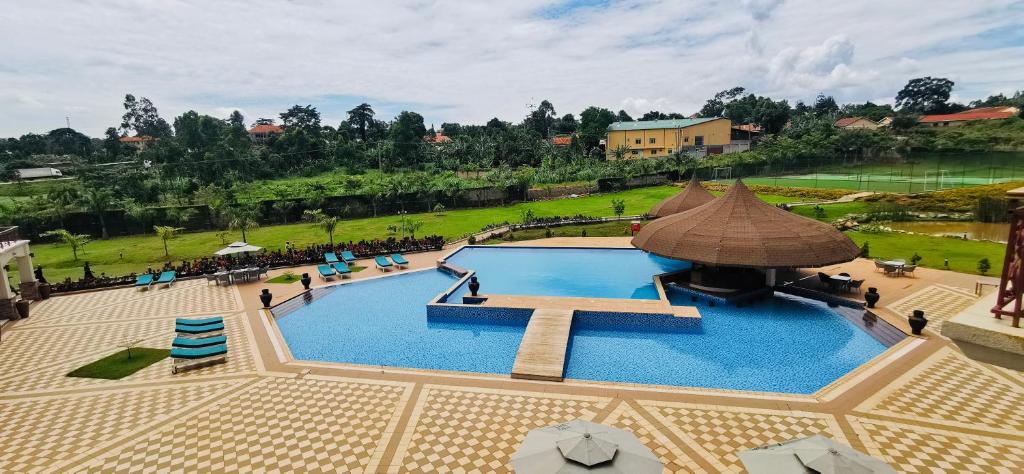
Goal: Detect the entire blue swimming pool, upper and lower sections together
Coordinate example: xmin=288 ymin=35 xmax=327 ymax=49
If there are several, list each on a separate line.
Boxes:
xmin=274 ymin=248 xmax=886 ymax=393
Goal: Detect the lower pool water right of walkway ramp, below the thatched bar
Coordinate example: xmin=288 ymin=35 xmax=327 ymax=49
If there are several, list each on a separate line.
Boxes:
xmin=565 ymin=287 xmax=886 ymax=393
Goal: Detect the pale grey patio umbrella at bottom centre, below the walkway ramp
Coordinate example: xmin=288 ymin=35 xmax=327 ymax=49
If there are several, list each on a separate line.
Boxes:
xmin=512 ymin=420 xmax=665 ymax=474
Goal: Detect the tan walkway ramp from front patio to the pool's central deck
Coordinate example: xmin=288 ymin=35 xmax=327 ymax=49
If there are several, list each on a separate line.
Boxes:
xmin=512 ymin=309 xmax=574 ymax=382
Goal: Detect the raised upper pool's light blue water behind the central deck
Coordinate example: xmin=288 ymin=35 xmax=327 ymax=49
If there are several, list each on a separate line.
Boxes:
xmin=447 ymin=247 xmax=690 ymax=302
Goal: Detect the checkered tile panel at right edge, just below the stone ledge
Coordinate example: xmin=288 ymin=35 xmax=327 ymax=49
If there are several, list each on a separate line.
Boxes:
xmin=857 ymin=348 xmax=1024 ymax=433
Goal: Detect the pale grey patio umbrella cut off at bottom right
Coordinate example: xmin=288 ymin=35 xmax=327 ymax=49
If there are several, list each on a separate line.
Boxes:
xmin=739 ymin=435 xmax=896 ymax=474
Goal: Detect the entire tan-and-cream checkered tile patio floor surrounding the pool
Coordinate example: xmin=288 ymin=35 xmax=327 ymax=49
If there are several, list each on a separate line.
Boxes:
xmin=0 ymin=248 xmax=1024 ymax=473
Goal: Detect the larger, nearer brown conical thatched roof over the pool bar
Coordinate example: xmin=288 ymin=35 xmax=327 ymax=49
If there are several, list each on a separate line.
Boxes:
xmin=633 ymin=180 xmax=860 ymax=268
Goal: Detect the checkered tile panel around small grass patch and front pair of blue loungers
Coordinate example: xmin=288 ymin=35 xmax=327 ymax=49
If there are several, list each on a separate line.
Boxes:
xmin=0 ymin=315 xmax=257 ymax=395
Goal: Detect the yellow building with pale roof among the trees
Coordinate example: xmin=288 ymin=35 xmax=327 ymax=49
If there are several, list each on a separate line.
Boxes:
xmin=605 ymin=118 xmax=732 ymax=160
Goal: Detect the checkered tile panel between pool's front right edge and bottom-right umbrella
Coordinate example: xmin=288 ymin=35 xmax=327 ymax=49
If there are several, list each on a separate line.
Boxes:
xmin=640 ymin=401 xmax=846 ymax=472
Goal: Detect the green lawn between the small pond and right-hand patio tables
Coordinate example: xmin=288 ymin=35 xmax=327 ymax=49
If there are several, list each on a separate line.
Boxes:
xmin=846 ymin=231 xmax=1007 ymax=276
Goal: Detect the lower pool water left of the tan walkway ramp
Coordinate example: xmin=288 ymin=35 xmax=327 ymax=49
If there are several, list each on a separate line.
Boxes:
xmin=276 ymin=270 xmax=528 ymax=374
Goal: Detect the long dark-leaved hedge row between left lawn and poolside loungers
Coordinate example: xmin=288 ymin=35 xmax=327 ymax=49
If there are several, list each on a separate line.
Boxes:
xmin=47 ymin=235 xmax=444 ymax=293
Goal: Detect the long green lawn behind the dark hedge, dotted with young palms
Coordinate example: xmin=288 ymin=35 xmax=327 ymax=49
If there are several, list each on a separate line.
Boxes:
xmin=25 ymin=186 xmax=798 ymax=282
